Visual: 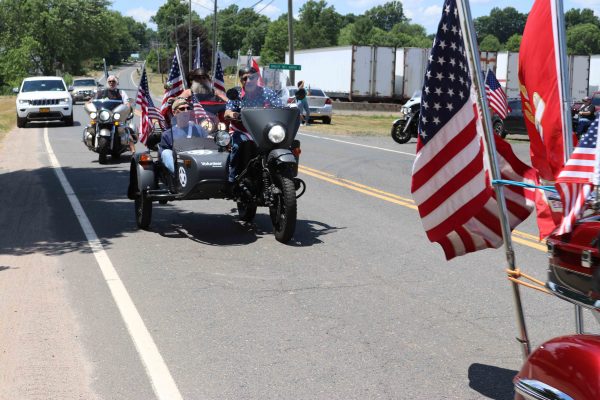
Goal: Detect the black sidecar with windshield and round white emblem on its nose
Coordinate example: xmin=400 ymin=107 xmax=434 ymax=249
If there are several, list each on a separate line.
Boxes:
xmin=127 ymin=110 xmax=230 ymax=229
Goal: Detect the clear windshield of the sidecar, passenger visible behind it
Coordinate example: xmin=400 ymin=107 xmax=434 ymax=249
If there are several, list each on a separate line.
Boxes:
xmin=169 ymin=108 xmax=219 ymax=154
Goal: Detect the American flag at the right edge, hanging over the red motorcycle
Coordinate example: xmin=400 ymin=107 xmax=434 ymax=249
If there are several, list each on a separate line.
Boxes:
xmin=555 ymin=115 xmax=600 ymax=235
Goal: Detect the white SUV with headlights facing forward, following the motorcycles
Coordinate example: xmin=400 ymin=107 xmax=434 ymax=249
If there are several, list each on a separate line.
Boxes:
xmin=17 ymin=76 xmax=73 ymax=128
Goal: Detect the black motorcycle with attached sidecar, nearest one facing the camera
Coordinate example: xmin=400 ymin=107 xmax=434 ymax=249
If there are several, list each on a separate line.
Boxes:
xmin=128 ymin=98 xmax=306 ymax=243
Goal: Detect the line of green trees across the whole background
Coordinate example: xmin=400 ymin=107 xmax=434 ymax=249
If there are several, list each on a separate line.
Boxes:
xmin=0 ymin=0 xmax=600 ymax=92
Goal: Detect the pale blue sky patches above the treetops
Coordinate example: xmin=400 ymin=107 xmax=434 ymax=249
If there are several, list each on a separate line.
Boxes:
xmin=113 ymin=0 xmax=600 ymax=33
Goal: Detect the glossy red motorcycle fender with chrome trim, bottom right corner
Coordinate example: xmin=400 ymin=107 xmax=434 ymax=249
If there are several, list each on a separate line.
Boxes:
xmin=513 ymin=335 xmax=600 ymax=400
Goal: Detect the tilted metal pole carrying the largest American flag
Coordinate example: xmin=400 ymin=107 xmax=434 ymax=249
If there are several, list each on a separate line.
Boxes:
xmin=457 ymin=0 xmax=530 ymax=359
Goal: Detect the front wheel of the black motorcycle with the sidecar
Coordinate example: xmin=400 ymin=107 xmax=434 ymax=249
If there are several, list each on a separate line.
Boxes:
xmin=269 ymin=170 xmax=297 ymax=243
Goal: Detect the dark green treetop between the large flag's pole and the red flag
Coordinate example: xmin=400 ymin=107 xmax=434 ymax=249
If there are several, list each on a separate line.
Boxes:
xmin=473 ymin=7 xmax=527 ymax=43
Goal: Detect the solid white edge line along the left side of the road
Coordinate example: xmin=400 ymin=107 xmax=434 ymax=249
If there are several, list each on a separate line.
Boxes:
xmin=44 ymin=127 xmax=183 ymax=400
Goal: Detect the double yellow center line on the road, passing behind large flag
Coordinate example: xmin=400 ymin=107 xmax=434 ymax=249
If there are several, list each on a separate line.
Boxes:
xmin=298 ymin=165 xmax=547 ymax=252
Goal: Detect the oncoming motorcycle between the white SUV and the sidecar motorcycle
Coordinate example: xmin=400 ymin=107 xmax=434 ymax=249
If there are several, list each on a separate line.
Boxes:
xmin=83 ymin=98 xmax=135 ymax=164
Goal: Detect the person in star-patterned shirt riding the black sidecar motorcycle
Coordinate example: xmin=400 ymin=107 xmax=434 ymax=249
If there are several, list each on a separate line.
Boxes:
xmin=225 ymin=67 xmax=283 ymax=182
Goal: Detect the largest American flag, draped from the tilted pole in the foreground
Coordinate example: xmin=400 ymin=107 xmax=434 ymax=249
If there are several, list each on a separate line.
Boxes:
xmin=411 ymin=0 xmax=535 ymax=259
